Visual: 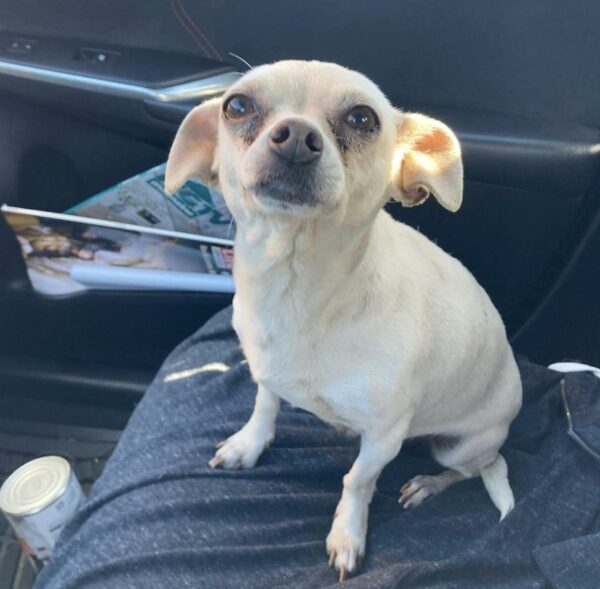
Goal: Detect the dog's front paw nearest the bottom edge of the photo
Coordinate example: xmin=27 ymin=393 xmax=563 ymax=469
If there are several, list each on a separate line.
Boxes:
xmin=326 ymin=513 xmax=367 ymax=583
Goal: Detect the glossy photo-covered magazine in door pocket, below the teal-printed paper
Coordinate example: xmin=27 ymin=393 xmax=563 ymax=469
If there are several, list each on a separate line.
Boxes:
xmin=0 ymin=205 xmax=234 ymax=295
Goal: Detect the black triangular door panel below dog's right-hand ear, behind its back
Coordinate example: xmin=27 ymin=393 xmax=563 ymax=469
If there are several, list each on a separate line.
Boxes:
xmin=389 ymin=182 xmax=580 ymax=332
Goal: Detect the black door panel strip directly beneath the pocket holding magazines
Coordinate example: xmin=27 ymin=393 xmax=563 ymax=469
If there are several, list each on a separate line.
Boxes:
xmin=0 ymin=289 xmax=231 ymax=370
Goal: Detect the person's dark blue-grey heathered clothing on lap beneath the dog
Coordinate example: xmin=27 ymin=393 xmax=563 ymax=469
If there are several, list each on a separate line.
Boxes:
xmin=36 ymin=310 xmax=600 ymax=589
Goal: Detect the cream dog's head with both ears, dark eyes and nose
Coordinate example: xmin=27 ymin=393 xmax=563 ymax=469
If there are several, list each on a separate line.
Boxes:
xmin=166 ymin=61 xmax=462 ymax=222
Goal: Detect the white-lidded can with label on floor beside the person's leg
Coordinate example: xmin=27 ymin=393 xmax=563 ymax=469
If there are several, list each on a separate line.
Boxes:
xmin=0 ymin=456 xmax=85 ymax=563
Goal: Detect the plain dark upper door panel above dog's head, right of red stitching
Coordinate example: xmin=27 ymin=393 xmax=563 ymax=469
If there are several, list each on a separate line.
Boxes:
xmin=211 ymin=0 xmax=600 ymax=126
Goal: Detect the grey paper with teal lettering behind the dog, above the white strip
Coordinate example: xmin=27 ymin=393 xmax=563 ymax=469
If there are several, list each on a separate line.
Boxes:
xmin=66 ymin=164 xmax=233 ymax=239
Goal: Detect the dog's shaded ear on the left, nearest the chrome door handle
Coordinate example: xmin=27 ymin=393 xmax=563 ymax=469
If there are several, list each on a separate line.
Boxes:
xmin=165 ymin=98 xmax=221 ymax=194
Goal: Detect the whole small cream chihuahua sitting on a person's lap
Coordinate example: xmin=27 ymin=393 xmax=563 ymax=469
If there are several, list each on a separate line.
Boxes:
xmin=166 ymin=61 xmax=521 ymax=580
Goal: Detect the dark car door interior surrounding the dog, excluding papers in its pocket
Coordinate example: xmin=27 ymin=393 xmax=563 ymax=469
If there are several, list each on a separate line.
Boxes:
xmin=0 ymin=0 xmax=600 ymax=589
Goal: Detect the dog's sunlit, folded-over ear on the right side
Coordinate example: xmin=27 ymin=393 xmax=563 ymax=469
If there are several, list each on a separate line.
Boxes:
xmin=392 ymin=113 xmax=463 ymax=213
